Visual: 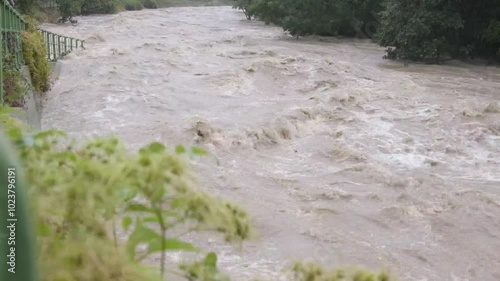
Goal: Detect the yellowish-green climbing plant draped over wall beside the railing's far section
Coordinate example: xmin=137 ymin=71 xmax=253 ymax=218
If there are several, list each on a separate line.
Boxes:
xmin=21 ymin=17 xmax=51 ymax=93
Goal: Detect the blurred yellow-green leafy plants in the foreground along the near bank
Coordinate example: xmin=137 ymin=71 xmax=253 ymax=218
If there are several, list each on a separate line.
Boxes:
xmin=0 ymin=108 xmax=394 ymax=281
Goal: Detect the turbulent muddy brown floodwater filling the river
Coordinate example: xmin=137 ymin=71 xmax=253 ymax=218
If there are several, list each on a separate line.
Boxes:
xmin=42 ymin=7 xmax=500 ymax=281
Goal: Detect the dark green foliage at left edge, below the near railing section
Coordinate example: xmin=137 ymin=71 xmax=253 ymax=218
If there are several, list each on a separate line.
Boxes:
xmin=2 ymin=53 xmax=28 ymax=107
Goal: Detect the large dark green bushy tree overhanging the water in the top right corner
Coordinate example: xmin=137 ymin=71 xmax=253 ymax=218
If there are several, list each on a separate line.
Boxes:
xmin=377 ymin=0 xmax=500 ymax=63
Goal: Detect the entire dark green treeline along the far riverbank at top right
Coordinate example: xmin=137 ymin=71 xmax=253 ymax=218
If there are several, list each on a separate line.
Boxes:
xmin=234 ymin=0 xmax=500 ymax=62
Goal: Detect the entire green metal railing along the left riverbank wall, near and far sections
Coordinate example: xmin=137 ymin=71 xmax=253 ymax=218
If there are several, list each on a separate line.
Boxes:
xmin=0 ymin=0 xmax=84 ymax=106
